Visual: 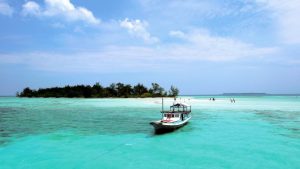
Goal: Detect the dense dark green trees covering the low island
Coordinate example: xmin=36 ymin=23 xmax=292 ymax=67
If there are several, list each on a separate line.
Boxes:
xmin=17 ymin=83 xmax=179 ymax=98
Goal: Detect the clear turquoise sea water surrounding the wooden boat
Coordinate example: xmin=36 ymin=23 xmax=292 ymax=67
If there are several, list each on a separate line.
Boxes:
xmin=0 ymin=96 xmax=300 ymax=169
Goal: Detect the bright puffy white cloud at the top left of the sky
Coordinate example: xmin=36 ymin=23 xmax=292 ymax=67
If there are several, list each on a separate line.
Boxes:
xmin=23 ymin=0 xmax=100 ymax=24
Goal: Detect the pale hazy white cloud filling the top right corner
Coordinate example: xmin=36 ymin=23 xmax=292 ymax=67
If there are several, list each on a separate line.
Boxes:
xmin=256 ymin=0 xmax=300 ymax=44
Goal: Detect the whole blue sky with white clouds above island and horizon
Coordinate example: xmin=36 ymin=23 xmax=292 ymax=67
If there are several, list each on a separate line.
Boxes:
xmin=0 ymin=0 xmax=300 ymax=95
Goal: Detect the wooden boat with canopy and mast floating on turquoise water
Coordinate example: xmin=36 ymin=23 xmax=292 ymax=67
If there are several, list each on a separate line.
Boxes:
xmin=150 ymin=100 xmax=192 ymax=133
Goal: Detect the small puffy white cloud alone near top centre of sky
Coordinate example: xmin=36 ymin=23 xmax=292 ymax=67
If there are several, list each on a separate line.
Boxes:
xmin=120 ymin=18 xmax=159 ymax=43
